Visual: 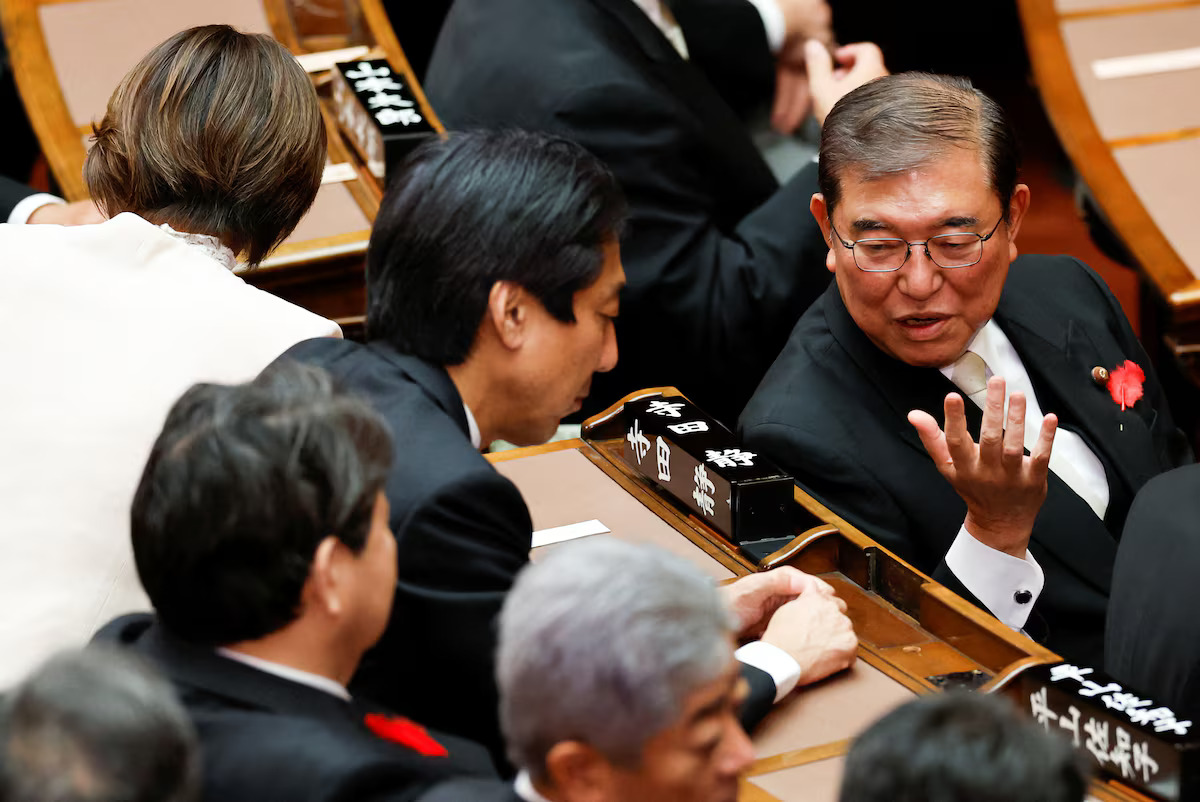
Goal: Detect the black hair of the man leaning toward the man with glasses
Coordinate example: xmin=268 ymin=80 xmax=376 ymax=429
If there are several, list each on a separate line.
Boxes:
xmin=367 ymin=131 xmax=625 ymax=365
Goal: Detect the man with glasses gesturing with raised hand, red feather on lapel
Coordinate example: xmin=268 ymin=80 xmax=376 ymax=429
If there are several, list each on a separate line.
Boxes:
xmin=740 ymin=73 xmax=1190 ymax=664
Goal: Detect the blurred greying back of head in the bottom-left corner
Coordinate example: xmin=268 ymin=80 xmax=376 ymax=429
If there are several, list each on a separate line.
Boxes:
xmin=0 ymin=648 xmax=199 ymax=802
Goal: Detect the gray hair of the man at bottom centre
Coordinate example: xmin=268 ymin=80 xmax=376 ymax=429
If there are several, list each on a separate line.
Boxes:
xmin=496 ymin=538 xmax=733 ymax=777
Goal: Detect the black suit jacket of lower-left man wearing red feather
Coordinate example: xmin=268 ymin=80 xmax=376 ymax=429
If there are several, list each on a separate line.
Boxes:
xmin=96 ymin=614 xmax=494 ymax=802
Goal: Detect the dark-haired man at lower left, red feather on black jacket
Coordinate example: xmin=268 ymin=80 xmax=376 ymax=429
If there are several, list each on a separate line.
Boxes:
xmin=97 ymin=363 xmax=493 ymax=802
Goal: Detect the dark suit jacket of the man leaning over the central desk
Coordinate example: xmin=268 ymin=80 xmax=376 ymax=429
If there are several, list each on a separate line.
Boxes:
xmin=280 ymin=337 xmax=775 ymax=761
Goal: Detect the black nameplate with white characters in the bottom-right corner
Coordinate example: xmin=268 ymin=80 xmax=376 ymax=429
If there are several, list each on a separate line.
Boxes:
xmin=1020 ymin=663 xmax=1200 ymax=801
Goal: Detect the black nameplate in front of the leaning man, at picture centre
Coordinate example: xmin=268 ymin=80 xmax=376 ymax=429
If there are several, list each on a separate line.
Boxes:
xmin=623 ymin=396 xmax=793 ymax=559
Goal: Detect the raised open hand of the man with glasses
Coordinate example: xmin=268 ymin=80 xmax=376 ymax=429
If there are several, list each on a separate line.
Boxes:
xmin=908 ymin=376 xmax=1058 ymax=558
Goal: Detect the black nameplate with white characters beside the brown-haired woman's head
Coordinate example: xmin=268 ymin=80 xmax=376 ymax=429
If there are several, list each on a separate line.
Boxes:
xmin=331 ymin=59 xmax=434 ymax=180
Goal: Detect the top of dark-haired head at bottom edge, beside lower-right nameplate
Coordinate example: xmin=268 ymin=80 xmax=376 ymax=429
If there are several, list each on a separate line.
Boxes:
xmin=839 ymin=692 xmax=1087 ymax=802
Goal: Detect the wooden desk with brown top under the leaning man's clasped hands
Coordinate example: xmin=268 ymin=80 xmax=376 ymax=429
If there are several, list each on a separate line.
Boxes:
xmin=488 ymin=388 xmax=1146 ymax=802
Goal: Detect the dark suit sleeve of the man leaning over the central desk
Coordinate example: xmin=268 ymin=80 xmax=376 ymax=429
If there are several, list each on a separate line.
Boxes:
xmin=355 ymin=466 xmax=533 ymax=765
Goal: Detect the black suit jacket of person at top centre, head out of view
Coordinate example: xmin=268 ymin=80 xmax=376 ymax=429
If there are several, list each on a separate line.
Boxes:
xmin=425 ymin=0 xmax=829 ymax=424
